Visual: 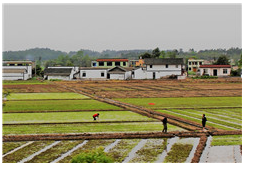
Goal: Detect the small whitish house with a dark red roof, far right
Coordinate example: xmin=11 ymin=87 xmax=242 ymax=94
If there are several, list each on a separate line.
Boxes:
xmin=199 ymin=65 xmax=231 ymax=77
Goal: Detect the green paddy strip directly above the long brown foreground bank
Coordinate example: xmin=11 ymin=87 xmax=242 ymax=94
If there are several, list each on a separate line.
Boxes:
xmin=3 ymin=122 xmax=183 ymax=135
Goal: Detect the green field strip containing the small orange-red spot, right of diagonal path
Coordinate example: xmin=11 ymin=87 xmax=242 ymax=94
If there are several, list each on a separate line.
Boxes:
xmin=116 ymin=97 xmax=242 ymax=109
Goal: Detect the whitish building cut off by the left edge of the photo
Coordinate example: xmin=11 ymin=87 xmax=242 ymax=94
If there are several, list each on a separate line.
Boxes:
xmin=2 ymin=61 xmax=34 ymax=80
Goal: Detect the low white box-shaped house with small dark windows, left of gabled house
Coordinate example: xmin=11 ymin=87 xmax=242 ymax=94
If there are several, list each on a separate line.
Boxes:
xmin=79 ymin=67 xmax=108 ymax=80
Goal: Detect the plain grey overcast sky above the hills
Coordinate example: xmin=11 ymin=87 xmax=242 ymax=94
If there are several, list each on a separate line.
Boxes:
xmin=2 ymin=4 xmax=242 ymax=52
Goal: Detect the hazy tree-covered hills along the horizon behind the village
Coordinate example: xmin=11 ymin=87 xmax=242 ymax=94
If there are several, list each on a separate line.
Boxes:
xmin=2 ymin=48 xmax=242 ymax=61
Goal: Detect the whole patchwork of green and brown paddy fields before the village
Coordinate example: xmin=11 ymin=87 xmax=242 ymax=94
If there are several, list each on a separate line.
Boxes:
xmin=2 ymin=80 xmax=242 ymax=163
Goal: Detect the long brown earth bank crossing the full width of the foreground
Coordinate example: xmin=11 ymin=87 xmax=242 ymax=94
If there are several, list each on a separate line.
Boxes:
xmin=2 ymin=130 xmax=242 ymax=142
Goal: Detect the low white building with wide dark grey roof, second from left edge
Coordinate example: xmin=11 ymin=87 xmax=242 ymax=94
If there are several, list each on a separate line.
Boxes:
xmin=44 ymin=67 xmax=79 ymax=80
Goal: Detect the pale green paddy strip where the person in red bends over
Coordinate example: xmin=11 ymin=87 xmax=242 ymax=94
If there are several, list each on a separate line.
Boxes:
xmin=2 ymin=111 xmax=155 ymax=124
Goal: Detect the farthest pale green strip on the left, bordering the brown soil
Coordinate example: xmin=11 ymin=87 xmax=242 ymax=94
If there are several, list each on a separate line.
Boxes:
xmin=7 ymin=93 xmax=89 ymax=100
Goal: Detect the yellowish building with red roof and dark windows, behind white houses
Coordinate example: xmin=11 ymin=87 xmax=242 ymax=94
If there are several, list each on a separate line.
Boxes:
xmin=91 ymin=59 xmax=129 ymax=68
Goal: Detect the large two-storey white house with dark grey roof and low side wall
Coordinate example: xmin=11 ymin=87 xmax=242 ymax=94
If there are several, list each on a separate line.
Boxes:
xmin=132 ymin=58 xmax=184 ymax=79
